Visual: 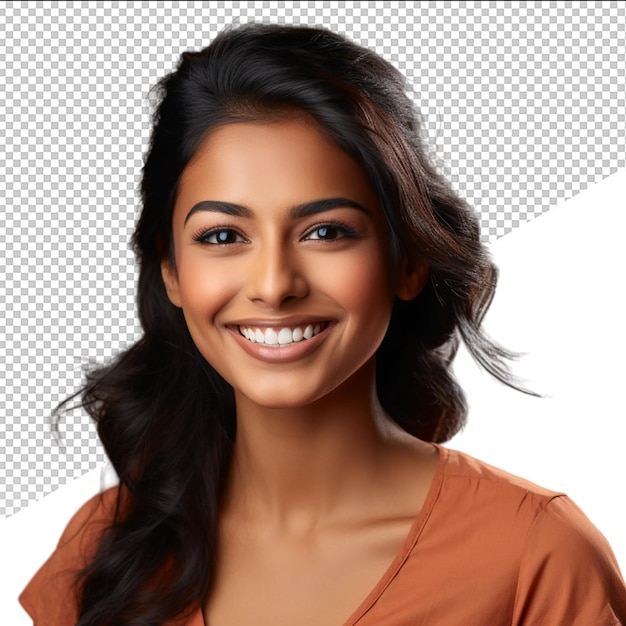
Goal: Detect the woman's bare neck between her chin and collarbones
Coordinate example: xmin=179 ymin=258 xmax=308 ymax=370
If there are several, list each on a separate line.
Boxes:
xmin=225 ymin=364 xmax=397 ymax=529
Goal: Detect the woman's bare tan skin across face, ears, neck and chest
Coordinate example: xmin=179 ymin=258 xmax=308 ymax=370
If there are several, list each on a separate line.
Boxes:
xmin=163 ymin=116 xmax=438 ymax=626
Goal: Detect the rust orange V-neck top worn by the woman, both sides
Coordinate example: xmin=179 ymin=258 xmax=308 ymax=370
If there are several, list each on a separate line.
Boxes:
xmin=20 ymin=447 xmax=626 ymax=626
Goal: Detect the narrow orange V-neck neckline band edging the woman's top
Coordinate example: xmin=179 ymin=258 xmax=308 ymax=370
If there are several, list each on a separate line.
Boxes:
xmin=193 ymin=443 xmax=449 ymax=626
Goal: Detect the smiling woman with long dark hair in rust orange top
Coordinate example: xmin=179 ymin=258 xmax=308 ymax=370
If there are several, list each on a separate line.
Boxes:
xmin=21 ymin=25 xmax=626 ymax=626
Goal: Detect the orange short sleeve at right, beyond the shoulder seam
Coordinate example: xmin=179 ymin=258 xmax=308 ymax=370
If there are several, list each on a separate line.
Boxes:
xmin=513 ymin=496 xmax=626 ymax=626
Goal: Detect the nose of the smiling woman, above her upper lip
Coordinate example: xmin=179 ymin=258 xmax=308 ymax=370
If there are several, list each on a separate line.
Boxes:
xmin=247 ymin=243 xmax=309 ymax=308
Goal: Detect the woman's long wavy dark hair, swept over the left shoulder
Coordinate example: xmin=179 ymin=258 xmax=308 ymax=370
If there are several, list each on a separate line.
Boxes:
xmin=66 ymin=24 xmax=514 ymax=626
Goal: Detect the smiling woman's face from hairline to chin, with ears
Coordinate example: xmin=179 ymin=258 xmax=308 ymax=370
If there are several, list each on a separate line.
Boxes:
xmin=163 ymin=117 xmax=422 ymax=408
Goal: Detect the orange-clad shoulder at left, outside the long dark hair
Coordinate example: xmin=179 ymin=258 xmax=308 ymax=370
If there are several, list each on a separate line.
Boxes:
xmin=19 ymin=487 xmax=120 ymax=626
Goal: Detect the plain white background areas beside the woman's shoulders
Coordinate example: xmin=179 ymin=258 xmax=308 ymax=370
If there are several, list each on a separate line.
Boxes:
xmin=0 ymin=170 xmax=626 ymax=626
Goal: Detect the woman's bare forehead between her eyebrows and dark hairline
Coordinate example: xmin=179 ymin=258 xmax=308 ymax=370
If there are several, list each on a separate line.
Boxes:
xmin=177 ymin=115 xmax=378 ymax=219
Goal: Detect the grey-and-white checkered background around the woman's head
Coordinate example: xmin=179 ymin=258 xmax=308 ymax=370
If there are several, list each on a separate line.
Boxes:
xmin=0 ymin=2 xmax=626 ymax=515
